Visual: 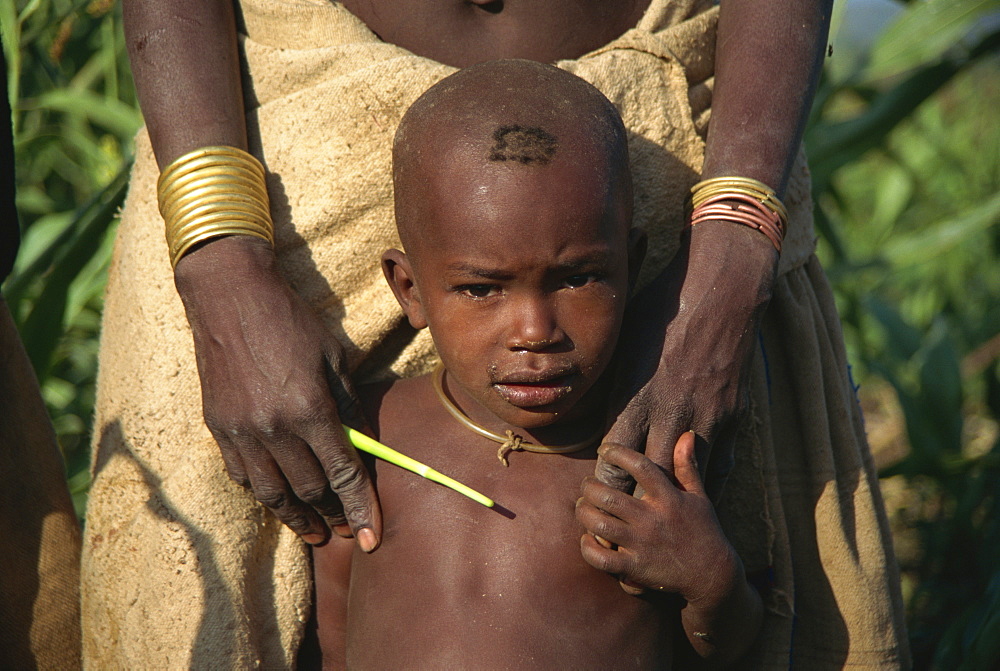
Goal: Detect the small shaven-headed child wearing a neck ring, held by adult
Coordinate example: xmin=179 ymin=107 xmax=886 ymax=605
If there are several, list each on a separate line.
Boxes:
xmin=314 ymin=61 xmax=760 ymax=669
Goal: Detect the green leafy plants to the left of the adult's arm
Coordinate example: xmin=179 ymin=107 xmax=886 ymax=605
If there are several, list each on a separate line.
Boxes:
xmin=0 ymin=0 xmax=141 ymax=511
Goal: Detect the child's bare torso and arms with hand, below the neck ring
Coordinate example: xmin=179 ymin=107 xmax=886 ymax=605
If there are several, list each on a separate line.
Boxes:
xmin=313 ymin=384 xmax=759 ymax=669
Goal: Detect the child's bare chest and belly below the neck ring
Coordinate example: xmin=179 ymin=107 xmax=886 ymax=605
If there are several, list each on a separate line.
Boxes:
xmin=348 ymin=388 xmax=668 ymax=668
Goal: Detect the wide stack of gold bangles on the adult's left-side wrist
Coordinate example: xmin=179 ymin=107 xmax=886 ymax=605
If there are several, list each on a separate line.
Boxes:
xmin=157 ymin=147 xmax=274 ymax=267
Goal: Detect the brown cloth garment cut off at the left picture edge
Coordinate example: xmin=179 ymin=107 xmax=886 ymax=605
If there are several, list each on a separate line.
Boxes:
xmin=0 ymin=298 xmax=80 ymax=671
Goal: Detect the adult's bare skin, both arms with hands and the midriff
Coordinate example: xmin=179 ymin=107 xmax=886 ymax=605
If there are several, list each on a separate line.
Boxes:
xmin=124 ymin=0 xmax=830 ymax=550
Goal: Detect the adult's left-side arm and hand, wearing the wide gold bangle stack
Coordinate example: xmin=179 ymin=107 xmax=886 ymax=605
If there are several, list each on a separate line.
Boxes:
xmin=118 ymin=0 xmax=381 ymax=550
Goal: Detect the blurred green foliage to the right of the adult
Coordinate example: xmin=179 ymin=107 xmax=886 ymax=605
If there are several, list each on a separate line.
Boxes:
xmin=807 ymin=0 xmax=1000 ymax=669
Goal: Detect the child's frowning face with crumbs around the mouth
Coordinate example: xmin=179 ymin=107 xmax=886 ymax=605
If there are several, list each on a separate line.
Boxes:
xmin=383 ymin=144 xmax=644 ymax=429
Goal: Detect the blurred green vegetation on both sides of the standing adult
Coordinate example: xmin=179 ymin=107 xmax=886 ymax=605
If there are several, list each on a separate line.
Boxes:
xmin=0 ymin=0 xmax=1000 ymax=669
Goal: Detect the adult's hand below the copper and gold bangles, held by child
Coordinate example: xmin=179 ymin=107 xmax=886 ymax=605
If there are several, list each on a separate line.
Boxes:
xmin=596 ymin=221 xmax=777 ymax=496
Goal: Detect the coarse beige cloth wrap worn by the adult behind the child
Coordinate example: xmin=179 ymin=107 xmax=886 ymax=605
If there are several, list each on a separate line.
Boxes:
xmin=82 ymin=0 xmax=906 ymax=669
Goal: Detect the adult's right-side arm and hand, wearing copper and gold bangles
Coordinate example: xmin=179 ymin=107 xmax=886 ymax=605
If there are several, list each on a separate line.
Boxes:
xmin=598 ymin=0 xmax=831 ymax=494
